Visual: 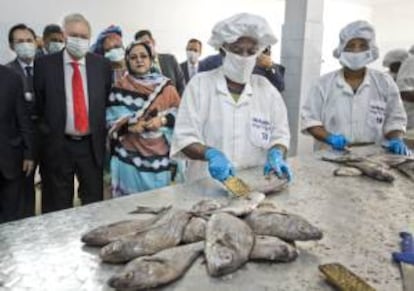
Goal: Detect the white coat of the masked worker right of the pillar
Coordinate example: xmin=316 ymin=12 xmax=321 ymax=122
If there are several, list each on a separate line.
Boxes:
xmin=301 ymin=68 xmax=407 ymax=147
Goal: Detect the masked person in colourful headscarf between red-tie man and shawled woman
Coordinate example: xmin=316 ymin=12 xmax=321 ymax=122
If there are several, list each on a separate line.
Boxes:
xmin=91 ymin=25 xmax=127 ymax=82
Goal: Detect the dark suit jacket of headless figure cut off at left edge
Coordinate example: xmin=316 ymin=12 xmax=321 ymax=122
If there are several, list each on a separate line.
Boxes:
xmin=0 ymin=65 xmax=33 ymax=179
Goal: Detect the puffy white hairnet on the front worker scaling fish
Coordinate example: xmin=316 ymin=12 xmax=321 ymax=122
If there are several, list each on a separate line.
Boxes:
xmin=208 ymin=13 xmax=277 ymax=49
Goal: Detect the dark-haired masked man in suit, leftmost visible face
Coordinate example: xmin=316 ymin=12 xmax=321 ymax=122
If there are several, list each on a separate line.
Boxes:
xmin=7 ymin=24 xmax=39 ymax=217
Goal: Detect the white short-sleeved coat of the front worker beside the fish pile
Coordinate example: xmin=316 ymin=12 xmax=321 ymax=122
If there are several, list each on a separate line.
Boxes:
xmin=171 ymin=68 xmax=290 ymax=181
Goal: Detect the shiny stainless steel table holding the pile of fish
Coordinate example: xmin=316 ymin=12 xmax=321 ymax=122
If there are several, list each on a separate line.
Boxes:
xmin=0 ymin=148 xmax=414 ymax=291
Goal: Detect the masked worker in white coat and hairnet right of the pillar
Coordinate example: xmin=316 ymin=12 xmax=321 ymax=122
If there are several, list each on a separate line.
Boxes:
xmin=301 ymin=21 xmax=410 ymax=155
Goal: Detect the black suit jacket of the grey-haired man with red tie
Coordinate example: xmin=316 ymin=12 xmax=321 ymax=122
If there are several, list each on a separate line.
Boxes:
xmin=34 ymin=51 xmax=112 ymax=169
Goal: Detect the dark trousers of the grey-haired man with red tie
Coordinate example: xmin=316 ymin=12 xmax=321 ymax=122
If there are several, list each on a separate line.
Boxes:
xmin=41 ymin=137 xmax=103 ymax=213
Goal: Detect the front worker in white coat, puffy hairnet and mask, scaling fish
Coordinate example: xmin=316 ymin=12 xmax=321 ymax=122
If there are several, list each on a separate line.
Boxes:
xmin=171 ymin=13 xmax=291 ymax=182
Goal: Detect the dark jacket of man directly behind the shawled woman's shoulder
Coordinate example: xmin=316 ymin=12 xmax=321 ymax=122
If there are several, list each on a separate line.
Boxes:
xmin=157 ymin=54 xmax=185 ymax=96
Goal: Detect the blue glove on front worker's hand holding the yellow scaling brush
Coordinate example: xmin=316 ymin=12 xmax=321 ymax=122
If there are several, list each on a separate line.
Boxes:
xmin=204 ymin=148 xmax=234 ymax=182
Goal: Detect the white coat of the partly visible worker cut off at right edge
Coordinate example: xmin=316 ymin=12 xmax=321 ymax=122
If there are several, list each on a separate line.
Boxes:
xmin=397 ymin=56 xmax=414 ymax=129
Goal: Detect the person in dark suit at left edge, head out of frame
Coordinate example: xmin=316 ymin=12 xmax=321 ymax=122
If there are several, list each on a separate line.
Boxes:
xmin=0 ymin=65 xmax=33 ymax=223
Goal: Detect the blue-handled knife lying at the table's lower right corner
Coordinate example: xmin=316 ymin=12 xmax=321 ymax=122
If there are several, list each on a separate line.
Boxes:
xmin=392 ymin=232 xmax=414 ymax=291
